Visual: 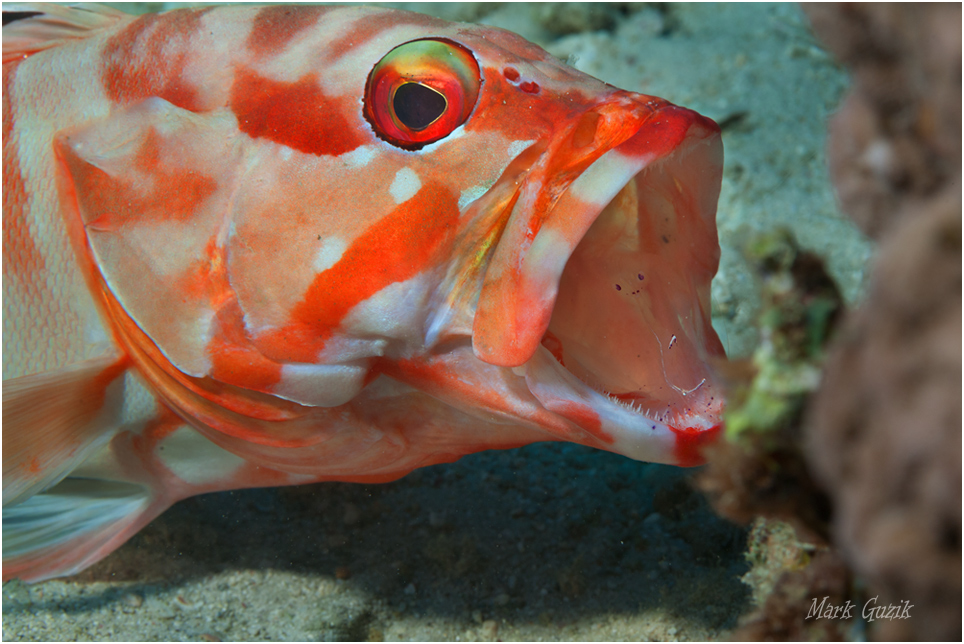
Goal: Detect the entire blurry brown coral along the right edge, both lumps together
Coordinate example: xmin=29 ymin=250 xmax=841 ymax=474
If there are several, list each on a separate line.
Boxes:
xmin=807 ymin=4 xmax=962 ymax=640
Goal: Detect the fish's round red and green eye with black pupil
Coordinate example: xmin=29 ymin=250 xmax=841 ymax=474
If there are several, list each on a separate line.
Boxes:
xmin=364 ymin=39 xmax=482 ymax=150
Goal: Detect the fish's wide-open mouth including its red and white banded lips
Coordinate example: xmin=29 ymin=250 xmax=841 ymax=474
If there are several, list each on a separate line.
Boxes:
xmin=473 ymin=106 xmax=723 ymax=464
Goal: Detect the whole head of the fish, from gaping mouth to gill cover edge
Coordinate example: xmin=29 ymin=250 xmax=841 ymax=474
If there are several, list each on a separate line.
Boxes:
xmin=56 ymin=6 xmax=723 ymax=471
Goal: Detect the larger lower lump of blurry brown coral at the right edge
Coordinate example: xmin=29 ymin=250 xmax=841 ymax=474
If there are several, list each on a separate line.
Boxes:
xmin=808 ymin=187 xmax=962 ymax=640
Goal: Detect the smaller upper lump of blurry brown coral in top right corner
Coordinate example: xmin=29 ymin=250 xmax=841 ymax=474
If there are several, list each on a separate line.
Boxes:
xmin=806 ymin=3 xmax=961 ymax=238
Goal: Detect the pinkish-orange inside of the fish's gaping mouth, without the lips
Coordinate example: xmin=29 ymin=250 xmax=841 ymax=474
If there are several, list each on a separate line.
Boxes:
xmin=542 ymin=149 xmax=723 ymax=422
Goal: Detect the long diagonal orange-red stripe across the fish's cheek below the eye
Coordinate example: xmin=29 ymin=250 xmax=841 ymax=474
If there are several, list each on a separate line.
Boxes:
xmin=255 ymin=183 xmax=459 ymax=362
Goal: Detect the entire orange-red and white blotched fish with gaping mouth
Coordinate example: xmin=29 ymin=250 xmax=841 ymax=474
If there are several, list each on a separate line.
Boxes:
xmin=3 ymin=5 xmax=723 ymax=581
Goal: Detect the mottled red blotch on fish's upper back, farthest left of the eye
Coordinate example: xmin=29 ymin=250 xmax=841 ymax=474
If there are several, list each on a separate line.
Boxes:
xmin=101 ymin=8 xmax=210 ymax=111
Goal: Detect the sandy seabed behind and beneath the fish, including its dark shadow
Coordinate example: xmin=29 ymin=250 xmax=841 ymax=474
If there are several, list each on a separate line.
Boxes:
xmin=3 ymin=3 xmax=872 ymax=641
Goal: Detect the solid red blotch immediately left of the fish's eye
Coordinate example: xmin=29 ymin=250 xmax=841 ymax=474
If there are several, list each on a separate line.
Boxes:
xmin=231 ymin=68 xmax=374 ymax=156
